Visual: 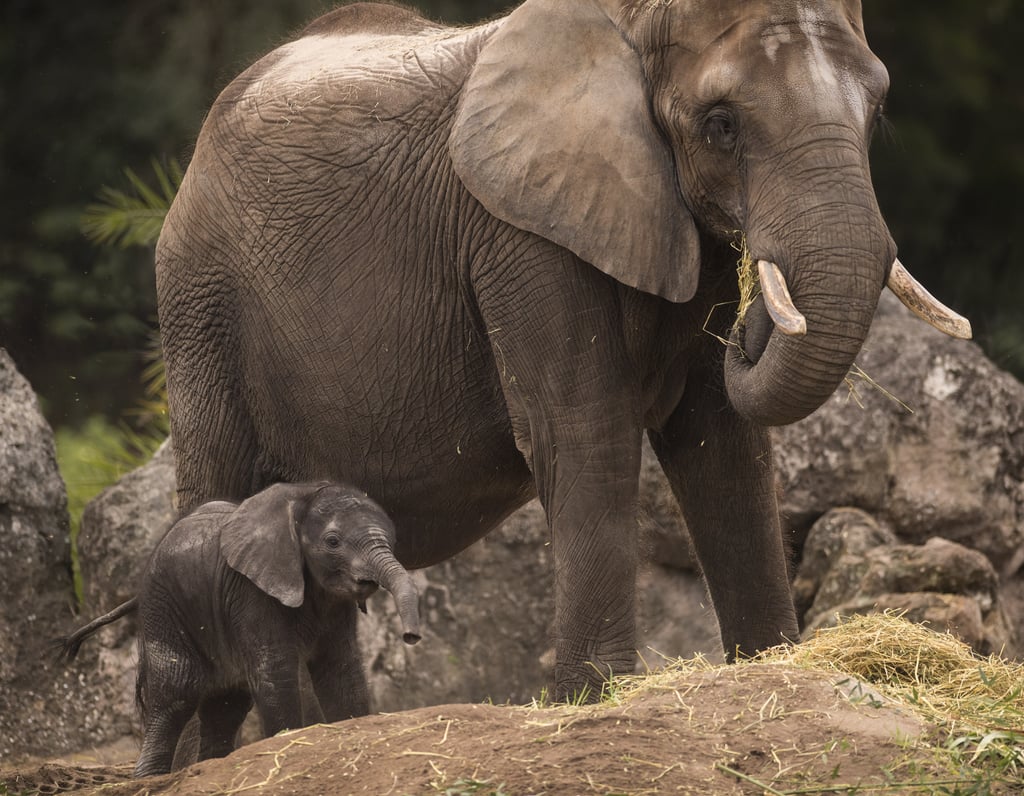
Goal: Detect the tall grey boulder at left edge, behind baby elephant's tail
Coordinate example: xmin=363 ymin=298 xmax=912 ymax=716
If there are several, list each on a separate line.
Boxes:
xmin=0 ymin=348 xmax=123 ymax=761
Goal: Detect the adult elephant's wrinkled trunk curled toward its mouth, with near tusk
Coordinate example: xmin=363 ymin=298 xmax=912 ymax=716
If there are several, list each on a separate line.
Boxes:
xmin=725 ymin=139 xmax=895 ymax=425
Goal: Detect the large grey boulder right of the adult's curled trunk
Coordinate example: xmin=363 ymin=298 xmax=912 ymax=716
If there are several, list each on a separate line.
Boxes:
xmin=775 ymin=292 xmax=1024 ymax=578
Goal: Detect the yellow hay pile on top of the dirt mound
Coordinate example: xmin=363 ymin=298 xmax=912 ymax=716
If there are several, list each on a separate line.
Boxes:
xmin=605 ymin=613 xmax=1024 ymax=793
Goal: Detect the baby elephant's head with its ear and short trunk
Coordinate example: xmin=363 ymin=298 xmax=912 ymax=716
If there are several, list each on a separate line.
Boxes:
xmin=220 ymin=483 xmax=420 ymax=644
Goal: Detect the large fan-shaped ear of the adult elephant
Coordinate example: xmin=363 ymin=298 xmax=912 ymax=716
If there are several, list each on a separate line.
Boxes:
xmin=449 ymin=0 xmax=699 ymax=302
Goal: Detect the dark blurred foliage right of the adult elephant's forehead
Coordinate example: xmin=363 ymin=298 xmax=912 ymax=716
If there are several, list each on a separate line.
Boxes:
xmin=863 ymin=0 xmax=1024 ymax=368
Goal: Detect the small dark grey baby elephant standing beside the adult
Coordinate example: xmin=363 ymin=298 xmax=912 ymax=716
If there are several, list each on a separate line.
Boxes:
xmin=63 ymin=484 xmax=420 ymax=777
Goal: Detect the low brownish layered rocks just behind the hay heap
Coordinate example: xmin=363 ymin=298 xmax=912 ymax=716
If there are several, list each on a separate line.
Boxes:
xmin=796 ymin=509 xmax=1016 ymax=655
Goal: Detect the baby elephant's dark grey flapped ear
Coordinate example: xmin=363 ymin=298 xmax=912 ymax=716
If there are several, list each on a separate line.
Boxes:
xmin=220 ymin=484 xmax=310 ymax=608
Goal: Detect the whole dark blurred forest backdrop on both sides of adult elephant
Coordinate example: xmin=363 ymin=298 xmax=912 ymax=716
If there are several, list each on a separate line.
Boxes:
xmin=0 ymin=0 xmax=1024 ymax=434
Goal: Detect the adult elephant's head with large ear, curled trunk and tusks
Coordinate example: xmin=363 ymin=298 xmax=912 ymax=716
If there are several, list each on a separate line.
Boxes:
xmin=450 ymin=0 xmax=970 ymax=425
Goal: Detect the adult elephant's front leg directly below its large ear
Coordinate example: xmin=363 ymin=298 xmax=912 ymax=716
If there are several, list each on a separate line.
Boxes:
xmin=480 ymin=242 xmax=642 ymax=699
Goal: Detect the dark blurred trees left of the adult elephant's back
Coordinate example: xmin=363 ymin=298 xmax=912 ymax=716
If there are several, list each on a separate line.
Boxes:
xmin=0 ymin=0 xmax=327 ymax=425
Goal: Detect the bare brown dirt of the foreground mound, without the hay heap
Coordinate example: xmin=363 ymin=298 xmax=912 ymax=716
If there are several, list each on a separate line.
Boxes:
xmin=0 ymin=663 xmax=962 ymax=796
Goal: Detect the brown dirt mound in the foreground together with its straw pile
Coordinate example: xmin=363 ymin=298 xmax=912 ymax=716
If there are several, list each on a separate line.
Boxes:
xmin=0 ymin=615 xmax=1024 ymax=796
